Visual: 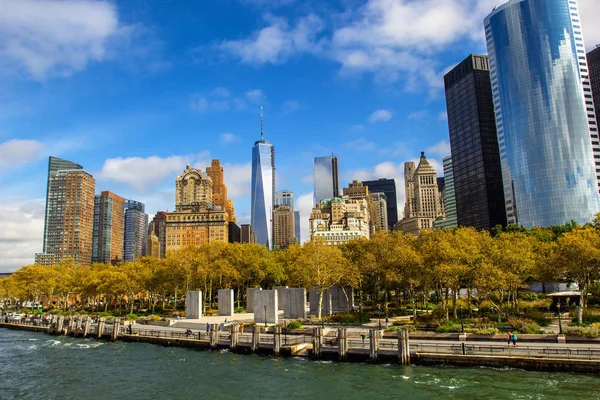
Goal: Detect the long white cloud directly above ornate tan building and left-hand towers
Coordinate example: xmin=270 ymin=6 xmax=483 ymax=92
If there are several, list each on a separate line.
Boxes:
xmin=96 ymin=153 xmax=210 ymax=193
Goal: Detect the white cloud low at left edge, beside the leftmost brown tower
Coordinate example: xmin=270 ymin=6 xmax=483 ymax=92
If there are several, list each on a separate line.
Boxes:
xmin=0 ymin=199 xmax=44 ymax=272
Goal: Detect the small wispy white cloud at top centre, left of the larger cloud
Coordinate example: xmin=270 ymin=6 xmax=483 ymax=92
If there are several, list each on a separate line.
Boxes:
xmin=217 ymin=14 xmax=325 ymax=65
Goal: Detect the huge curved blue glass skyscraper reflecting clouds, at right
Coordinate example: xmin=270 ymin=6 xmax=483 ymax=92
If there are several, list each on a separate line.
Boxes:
xmin=484 ymin=0 xmax=600 ymax=228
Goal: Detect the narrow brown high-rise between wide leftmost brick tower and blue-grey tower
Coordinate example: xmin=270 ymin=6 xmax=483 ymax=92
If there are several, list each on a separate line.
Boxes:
xmin=92 ymin=192 xmax=125 ymax=263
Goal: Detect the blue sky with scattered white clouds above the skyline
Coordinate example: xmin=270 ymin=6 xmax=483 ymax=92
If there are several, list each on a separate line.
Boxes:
xmin=0 ymin=0 xmax=600 ymax=272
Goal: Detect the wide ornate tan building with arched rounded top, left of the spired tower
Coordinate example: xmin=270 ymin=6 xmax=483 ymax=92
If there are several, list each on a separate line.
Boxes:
xmin=165 ymin=164 xmax=233 ymax=254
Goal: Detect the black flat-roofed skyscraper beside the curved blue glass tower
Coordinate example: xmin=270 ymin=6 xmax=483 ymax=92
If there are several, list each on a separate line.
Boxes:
xmin=444 ymin=54 xmax=506 ymax=230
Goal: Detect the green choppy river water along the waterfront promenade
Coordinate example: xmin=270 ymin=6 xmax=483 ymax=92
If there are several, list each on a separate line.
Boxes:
xmin=0 ymin=329 xmax=600 ymax=400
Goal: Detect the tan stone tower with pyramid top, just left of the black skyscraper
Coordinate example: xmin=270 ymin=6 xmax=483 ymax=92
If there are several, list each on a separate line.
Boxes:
xmin=398 ymin=152 xmax=444 ymax=235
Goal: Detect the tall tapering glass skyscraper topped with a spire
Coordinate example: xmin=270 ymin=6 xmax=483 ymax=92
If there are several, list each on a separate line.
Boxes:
xmin=250 ymin=108 xmax=275 ymax=249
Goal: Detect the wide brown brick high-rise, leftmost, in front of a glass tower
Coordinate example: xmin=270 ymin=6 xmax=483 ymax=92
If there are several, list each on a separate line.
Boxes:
xmin=44 ymin=169 xmax=96 ymax=266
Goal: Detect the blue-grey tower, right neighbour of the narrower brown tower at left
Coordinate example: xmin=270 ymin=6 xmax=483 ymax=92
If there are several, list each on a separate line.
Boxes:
xmin=123 ymin=200 xmax=148 ymax=261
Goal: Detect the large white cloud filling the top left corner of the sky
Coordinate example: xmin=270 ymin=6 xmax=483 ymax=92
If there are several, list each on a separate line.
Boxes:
xmin=0 ymin=0 xmax=122 ymax=80
